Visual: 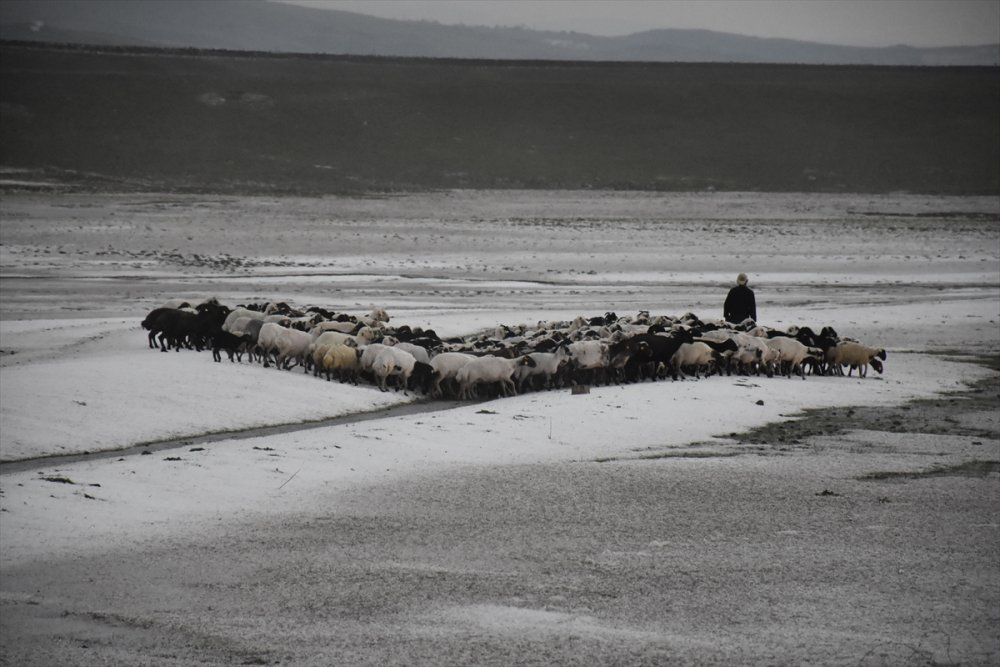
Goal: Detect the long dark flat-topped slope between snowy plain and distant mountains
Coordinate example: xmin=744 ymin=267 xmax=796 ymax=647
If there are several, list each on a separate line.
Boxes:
xmin=0 ymin=43 xmax=1000 ymax=194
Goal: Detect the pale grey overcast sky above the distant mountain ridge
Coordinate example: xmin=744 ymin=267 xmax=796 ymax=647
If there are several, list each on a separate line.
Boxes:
xmin=282 ymin=0 xmax=1000 ymax=46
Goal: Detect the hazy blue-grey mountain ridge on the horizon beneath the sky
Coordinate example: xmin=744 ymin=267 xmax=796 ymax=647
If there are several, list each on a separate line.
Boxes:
xmin=0 ymin=0 xmax=1000 ymax=67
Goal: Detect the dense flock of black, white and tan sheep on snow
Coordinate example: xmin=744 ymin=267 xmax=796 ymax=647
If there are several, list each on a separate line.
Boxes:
xmin=142 ymin=299 xmax=886 ymax=399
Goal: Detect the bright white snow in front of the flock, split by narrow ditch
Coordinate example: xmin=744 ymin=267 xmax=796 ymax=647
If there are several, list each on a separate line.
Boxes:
xmin=0 ymin=321 xmax=988 ymax=563
